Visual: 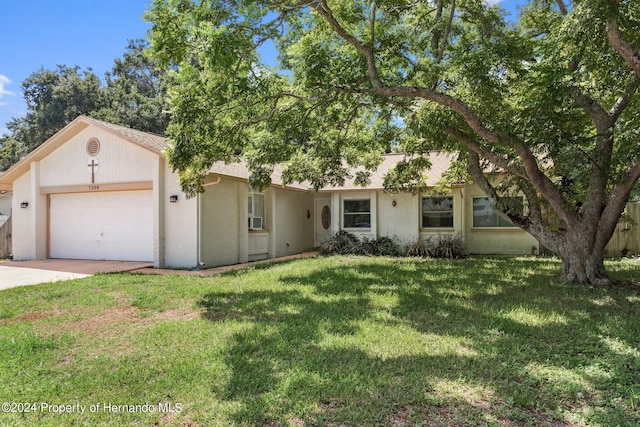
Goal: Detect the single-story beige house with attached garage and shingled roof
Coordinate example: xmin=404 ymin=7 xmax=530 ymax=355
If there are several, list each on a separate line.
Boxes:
xmin=0 ymin=116 xmax=538 ymax=268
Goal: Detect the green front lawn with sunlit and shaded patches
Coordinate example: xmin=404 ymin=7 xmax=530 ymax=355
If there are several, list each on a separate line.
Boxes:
xmin=0 ymin=257 xmax=640 ymax=426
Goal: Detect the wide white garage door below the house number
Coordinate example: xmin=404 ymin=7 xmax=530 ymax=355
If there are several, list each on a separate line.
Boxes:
xmin=49 ymin=191 xmax=153 ymax=261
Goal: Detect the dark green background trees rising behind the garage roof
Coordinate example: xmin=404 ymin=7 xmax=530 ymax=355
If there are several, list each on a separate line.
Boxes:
xmin=0 ymin=40 xmax=170 ymax=170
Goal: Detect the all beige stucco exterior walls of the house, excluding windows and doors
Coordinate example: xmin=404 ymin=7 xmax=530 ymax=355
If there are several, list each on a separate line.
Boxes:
xmin=7 ymin=121 xmax=538 ymax=268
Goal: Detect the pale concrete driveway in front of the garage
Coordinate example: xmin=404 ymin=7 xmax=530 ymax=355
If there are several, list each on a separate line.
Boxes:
xmin=0 ymin=259 xmax=153 ymax=290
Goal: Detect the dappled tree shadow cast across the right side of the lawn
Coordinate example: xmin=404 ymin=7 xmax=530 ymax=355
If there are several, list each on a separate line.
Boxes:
xmin=201 ymin=259 xmax=640 ymax=426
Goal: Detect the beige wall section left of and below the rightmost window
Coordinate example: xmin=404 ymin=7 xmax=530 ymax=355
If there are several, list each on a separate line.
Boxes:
xmin=464 ymin=185 xmax=538 ymax=255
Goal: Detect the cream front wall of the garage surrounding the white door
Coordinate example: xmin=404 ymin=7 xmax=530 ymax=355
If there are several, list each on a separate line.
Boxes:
xmin=13 ymin=126 xmax=180 ymax=266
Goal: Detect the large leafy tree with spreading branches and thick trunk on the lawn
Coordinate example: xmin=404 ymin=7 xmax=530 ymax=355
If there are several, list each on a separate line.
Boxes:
xmin=148 ymin=0 xmax=640 ymax=284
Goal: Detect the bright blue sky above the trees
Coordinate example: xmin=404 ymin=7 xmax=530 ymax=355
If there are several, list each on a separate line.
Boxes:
xmin=0 ymin=0 xmax=523 ymax=134
